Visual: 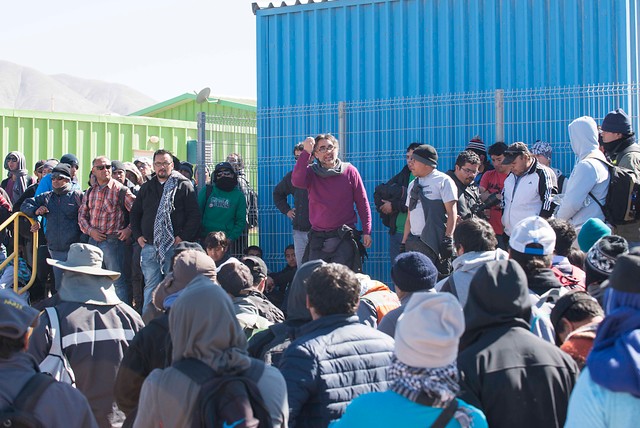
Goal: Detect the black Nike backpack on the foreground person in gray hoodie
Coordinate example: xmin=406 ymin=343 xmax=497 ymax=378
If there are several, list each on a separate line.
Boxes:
xmin=173 ymin=358 xmax=273 ymax=428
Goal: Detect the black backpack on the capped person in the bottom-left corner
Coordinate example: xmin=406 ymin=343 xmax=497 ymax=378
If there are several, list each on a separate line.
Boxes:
xmin=0 ymin=373 xmax=55 ymax=428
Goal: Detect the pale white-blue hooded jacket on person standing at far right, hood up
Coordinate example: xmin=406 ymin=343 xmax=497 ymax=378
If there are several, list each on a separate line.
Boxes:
xmin=556 ymin=116 xmax=609 ymax=230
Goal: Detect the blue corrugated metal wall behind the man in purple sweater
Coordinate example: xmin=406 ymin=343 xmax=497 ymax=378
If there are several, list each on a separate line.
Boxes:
xmin=256 ymin=0 xmax=638 ymax=280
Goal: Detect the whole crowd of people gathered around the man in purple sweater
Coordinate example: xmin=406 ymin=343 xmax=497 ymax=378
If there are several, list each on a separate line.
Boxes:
xmin=0 ymin=109 xmax=640 ymax=427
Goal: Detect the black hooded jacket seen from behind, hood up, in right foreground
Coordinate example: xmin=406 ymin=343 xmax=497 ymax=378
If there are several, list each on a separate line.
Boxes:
xmin=458 ymin=260 xmax=579 ymax=428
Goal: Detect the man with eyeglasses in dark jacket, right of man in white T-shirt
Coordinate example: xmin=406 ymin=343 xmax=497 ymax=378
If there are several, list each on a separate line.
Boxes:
xmin=447 ymin=150 xmax=486 ymax=221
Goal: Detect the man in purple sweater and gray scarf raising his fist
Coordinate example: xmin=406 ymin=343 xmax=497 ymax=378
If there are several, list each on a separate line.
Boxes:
xmin=291 ymin=134 xmax=371 ymax=272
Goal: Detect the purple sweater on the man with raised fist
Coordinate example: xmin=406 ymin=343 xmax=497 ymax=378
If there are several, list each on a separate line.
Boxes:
xmin=291 ymin=151 xmax=371 ymax=235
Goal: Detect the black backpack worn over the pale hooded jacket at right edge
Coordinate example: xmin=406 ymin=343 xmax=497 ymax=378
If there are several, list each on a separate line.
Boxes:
xmin=589 ymin=148 xmax=640 ymax=226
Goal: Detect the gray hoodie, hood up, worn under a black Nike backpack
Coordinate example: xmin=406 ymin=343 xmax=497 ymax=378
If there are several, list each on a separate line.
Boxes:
xmin=134 ymin=275 xmax=289 ymax=427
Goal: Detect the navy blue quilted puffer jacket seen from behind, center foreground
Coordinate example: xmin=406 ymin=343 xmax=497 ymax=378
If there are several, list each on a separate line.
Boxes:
xmin=280 ymin=315 xmax=394 ymax=428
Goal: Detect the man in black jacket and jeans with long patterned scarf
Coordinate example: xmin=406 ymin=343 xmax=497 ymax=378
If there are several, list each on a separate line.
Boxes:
xmin=131 ymin=149 xmax=202 ymax=315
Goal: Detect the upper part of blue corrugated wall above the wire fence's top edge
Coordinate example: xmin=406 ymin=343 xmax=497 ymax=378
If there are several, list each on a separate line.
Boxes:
xmin=256 ymin=0 xmax=638 ymax=108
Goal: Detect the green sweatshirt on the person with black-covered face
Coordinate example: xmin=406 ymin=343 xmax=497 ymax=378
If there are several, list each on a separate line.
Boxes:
xmin=198 ymin=185 xmax=247 ymax=240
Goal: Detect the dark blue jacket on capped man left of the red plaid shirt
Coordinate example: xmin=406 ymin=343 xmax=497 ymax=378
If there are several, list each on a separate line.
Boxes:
xmin=20 ymin=190 xmax=82 ymax=251
